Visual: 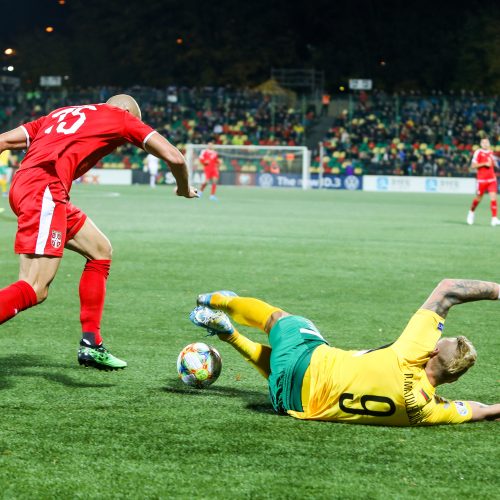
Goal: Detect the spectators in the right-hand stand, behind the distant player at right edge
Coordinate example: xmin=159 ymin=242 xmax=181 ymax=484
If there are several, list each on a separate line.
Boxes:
xmin=316 ymin=92 xmax=500 ymax=176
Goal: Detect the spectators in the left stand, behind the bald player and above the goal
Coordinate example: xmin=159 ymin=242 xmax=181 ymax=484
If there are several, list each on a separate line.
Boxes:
xmin=2 ymin=86 xmax=308 ymax=168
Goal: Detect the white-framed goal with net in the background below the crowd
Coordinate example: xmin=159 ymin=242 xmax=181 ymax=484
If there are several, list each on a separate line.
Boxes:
xmin=186 ymin=144 xmax=310 ymax=189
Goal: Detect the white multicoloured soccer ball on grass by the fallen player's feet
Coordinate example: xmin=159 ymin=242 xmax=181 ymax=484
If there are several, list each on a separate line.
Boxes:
xmin=177 ymin=342 xmax=222 ymax=389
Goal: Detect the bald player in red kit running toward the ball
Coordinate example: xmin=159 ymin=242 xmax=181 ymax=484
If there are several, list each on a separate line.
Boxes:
xmin=0 ymin=94 xmax=197 ymax=370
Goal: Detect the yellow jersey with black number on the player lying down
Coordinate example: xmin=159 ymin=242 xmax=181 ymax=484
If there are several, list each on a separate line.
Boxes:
xmin=288 ymin=309 xmax=472 ymax=426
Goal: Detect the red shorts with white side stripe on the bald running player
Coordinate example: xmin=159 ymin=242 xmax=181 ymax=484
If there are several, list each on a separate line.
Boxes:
xmin=9 ymin=167 xmax=87 ymax=257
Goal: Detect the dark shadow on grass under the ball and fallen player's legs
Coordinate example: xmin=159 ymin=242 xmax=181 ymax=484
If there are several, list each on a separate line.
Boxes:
xmin=161 ymin=379 xmax=275 ymax=414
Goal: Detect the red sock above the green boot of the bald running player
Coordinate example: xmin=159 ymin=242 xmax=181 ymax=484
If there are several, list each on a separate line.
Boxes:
xmin=79 ymin=260 xmax=111 ymax=345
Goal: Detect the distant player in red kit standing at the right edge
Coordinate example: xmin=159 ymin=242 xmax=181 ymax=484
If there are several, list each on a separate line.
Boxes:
xmin=467 ymin=138 xmax=500 ymax=226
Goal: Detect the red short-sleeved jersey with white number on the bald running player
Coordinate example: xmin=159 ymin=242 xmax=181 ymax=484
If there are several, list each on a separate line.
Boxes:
xmin=20 ymin=104 xmax=155 ymax=193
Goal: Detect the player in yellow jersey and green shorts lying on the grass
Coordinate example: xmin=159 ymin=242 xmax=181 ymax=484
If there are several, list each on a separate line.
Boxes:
xmin=190 ymin=279 xmax=500 ymax=426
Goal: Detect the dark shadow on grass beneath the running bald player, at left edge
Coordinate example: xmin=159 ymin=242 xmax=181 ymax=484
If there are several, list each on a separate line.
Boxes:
xmin=0 ymin=354 xmax=115 ymax=390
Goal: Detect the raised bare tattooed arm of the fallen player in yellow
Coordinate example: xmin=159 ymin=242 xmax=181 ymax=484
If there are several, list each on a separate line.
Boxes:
xmin=422 ymin=279 xmax=500 ymax=318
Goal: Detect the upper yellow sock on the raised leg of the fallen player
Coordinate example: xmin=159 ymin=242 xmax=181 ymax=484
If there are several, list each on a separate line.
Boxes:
xmin=210 ymin=293 xmax=281 ymax=331
